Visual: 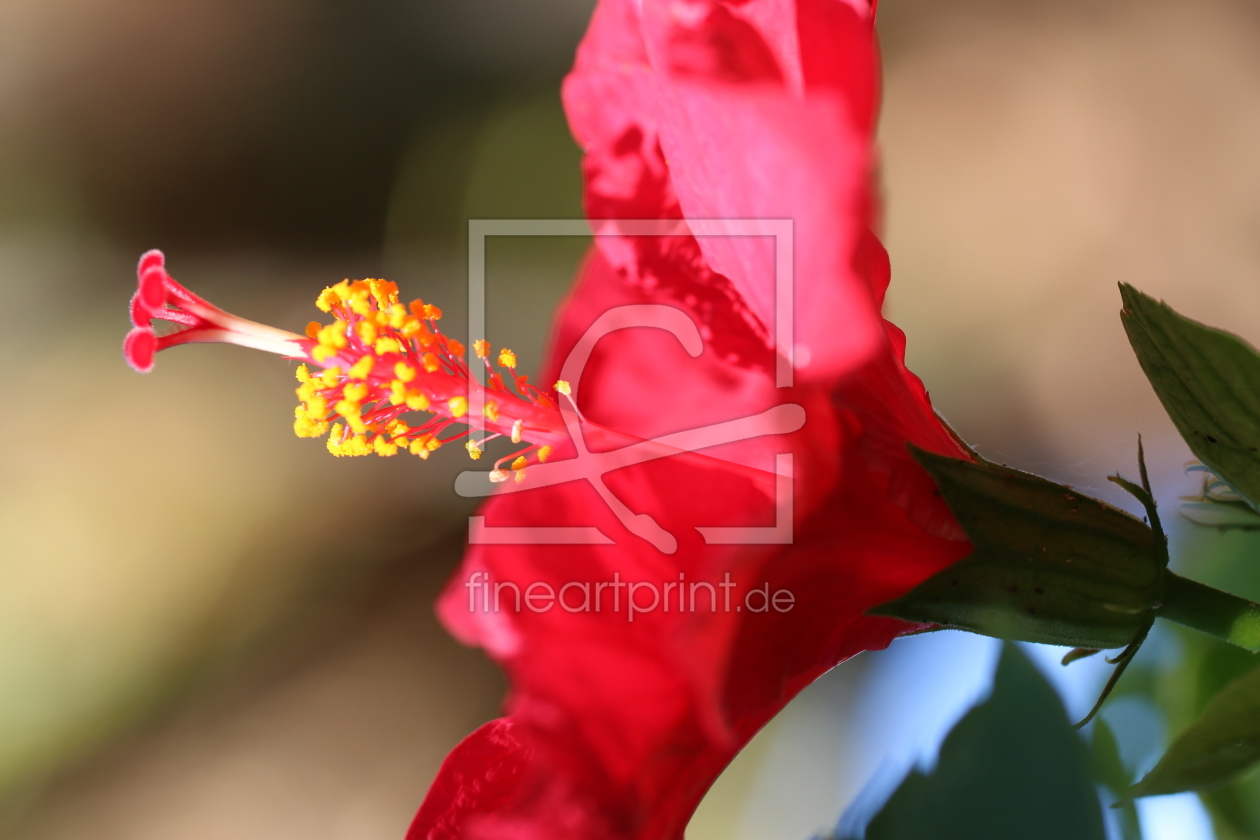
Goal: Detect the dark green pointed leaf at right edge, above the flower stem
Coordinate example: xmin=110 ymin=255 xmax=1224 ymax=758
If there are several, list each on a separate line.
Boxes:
xmin=1120 ymin=283 xmax=1260 ymax=510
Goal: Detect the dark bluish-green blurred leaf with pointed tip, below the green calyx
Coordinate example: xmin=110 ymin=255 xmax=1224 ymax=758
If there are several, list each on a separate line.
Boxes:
xmin=866 ymin=645 xmax=1105 ymax=840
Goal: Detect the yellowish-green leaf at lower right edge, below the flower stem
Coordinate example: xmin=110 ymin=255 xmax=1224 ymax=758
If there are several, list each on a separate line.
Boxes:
xmin=1130 ymin=667 xmax=1260 ymax=796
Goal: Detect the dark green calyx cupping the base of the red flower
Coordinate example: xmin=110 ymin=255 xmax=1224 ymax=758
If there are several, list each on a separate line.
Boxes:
xmin=871 ymin=447 xmax=1163 ymax=649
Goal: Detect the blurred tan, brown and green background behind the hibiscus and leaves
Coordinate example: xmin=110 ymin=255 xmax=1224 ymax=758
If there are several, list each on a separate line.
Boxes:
xmin=0 ymin=0 xmax=1260 ymax=840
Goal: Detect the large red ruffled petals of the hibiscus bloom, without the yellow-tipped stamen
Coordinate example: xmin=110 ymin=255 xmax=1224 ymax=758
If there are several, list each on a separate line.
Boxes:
xmin=408 ymin=0 xmax=969 ymax=840
